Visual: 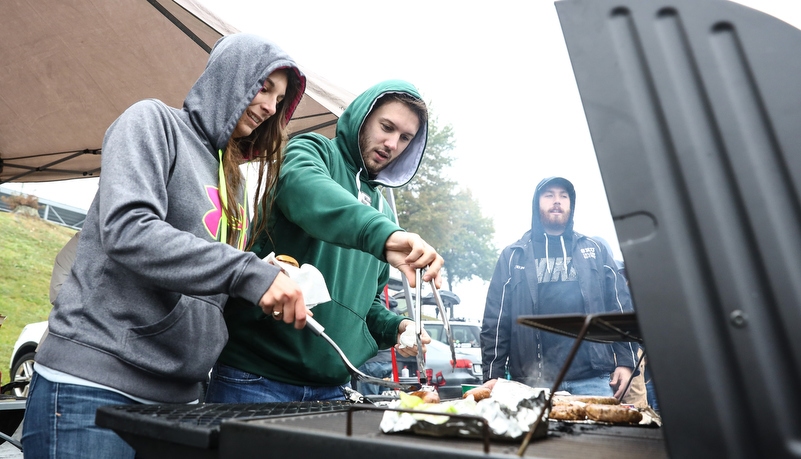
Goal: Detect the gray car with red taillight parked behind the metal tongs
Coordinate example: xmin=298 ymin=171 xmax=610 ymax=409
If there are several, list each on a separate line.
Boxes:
xmin=397 ymin=340 xmax=483 ymax=400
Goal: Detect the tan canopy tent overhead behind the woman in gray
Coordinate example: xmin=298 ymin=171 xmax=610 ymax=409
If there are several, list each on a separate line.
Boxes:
xmin=0 ymin=0 xmax=354 ymax=184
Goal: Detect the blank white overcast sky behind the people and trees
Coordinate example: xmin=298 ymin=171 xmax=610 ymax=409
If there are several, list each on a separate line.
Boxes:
xmin=3 ymin=0 xmax=801 ymax=317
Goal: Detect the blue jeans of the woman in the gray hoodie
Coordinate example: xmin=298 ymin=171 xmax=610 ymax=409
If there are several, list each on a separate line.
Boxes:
xmin=22 ymin=373 xmax=137 ymax=459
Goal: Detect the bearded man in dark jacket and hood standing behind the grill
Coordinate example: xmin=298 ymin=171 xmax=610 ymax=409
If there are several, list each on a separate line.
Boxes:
xmin=481 ymin=177 xmax=637 ymax=396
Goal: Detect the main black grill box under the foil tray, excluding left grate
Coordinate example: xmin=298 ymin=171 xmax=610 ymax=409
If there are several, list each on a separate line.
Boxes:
xmin=219 ymin=411 xmax=668 ymax=459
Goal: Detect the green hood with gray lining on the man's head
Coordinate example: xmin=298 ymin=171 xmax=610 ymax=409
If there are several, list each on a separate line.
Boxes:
xmin=336 ymin=80 xmax=428 ymax=188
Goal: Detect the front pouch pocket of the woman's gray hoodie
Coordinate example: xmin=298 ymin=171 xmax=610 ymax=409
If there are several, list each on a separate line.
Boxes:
xmin=121 ymin=296 xmax=228 ymax=382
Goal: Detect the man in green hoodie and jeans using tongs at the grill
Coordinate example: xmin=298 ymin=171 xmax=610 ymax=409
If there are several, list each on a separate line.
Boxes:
xmin=206 ymin=80 xmax=443 ymax=403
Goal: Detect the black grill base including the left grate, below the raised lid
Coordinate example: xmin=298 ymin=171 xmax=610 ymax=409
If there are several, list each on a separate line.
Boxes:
xmin=97 ymin=402 xmax=668 ymax=459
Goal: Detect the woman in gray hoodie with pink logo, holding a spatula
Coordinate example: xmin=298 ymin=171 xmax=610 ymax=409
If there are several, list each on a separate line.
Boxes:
xmin=22 ymin=34 xmax=306 ymax=458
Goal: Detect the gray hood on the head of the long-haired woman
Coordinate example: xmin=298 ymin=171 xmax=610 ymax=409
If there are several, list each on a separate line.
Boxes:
xmin=184 ymin=33 xmax=306 ymax=154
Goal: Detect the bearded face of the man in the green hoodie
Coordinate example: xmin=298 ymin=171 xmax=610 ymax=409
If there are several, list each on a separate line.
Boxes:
xmin=359 ymin=100 xmax=420 ymax=177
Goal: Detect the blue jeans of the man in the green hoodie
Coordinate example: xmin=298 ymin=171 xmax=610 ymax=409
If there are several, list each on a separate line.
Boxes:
xmin=206 ymin=363 xmax=350 ymax=403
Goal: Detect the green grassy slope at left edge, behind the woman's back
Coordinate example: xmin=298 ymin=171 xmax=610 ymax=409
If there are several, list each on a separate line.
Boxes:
xmin=0 ymin=212 xmax=75 ymax=384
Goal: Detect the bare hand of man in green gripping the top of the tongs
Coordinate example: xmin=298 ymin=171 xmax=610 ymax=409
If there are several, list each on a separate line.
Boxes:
xmin=384 ymin=231 xmax=445 ymax=288
